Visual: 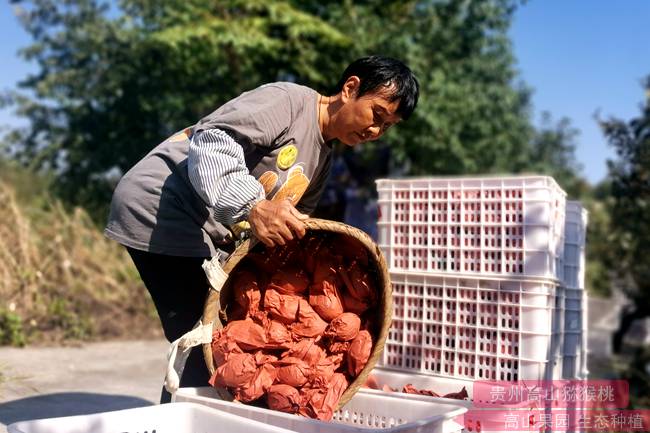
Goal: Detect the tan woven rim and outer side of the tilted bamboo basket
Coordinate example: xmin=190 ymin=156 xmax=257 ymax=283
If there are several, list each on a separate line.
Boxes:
xmin=202 ymin=218 xmax=393 ymax=409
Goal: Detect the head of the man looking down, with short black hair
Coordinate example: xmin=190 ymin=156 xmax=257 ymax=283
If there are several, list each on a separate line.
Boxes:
xmin=326 ymin=56 xmax=419 ymax=146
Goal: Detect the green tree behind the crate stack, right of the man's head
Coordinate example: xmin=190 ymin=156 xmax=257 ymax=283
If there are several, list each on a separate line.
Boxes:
xmin=296 ymin=0 xmax=532 ymax=181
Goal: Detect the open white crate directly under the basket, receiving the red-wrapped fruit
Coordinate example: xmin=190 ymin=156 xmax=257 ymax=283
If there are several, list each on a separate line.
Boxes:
xmin=174 ymin=387 xmax=467 ymax=433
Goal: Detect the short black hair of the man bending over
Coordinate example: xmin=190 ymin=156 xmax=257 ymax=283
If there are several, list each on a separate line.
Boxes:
xmin=336 ymin=56 xmax=420 ymax=120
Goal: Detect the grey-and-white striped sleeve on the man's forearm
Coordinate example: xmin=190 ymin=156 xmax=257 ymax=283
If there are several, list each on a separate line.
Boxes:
xmin=187 ymin=129 xmax=264 ymax=225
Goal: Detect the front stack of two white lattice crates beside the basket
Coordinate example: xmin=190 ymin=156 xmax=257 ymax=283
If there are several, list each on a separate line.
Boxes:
xmin=377 ymin=176 xmax=566 ymax=381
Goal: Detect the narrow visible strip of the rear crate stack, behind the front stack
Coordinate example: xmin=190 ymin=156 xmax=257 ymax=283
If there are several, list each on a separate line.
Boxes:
xmin=561 ymin=201 xmax=589 ymax=379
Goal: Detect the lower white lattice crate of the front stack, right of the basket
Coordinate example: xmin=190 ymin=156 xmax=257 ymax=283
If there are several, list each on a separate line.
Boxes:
xmin=381 ymin=272 xmax=556 ymax=380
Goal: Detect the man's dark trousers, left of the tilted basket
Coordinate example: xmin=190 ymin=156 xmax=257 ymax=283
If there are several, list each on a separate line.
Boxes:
xmin=127 ymin=248 xmax=210 ymax=403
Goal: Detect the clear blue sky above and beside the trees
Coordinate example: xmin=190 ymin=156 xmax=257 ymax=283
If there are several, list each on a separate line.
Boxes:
xmin=0 ymin=0 xmax=650 ymax=182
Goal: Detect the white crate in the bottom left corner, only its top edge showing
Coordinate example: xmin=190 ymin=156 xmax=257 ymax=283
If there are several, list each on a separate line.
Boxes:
xmin=7 ymin=403 xmax=291 ymax=433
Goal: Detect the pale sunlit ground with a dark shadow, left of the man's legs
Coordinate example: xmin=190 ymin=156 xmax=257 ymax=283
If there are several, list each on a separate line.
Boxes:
xmin=0 ymin=340 xmax=169 ymax=433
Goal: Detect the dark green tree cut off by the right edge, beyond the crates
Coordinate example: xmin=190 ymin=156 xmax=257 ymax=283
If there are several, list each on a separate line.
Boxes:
xmin=601 ymin=76 xmax=650 ymax=350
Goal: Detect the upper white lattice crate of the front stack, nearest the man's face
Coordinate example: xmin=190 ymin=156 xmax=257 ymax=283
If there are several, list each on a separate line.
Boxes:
xmin=377 ymin=176 xmax=566 ymax=279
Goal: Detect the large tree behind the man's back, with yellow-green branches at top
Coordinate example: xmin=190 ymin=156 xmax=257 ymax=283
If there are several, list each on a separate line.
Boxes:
xmin=7 ymin=0 xmax=351 ymax=216
